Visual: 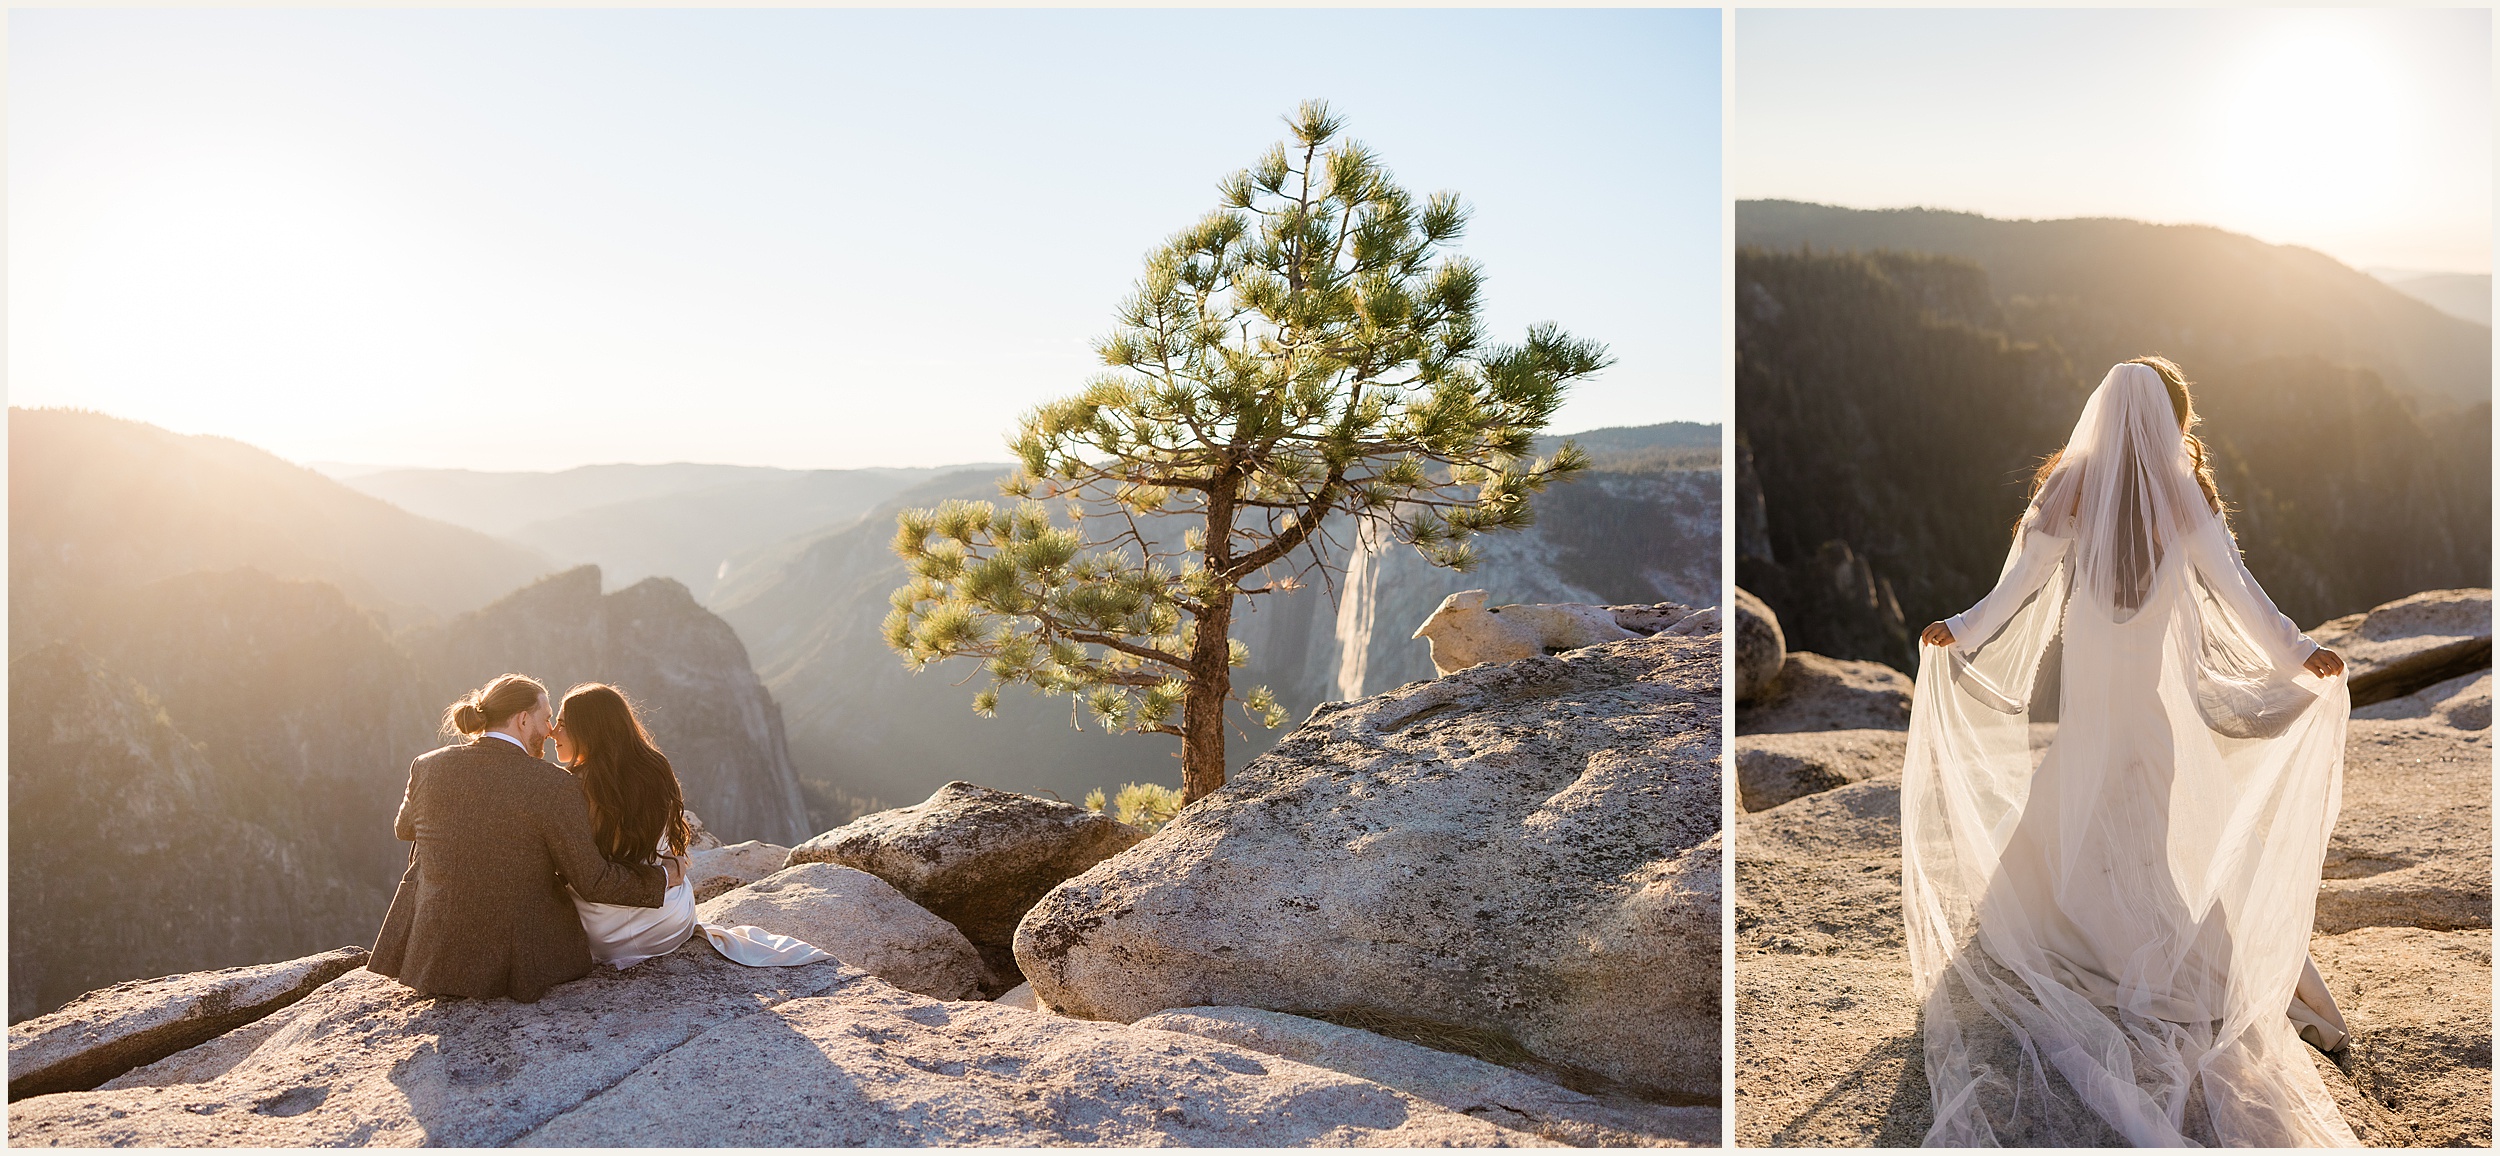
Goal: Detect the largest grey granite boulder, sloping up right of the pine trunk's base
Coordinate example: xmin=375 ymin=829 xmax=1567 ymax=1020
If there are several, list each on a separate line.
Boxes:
xmin=1015 ymin=633 xmax=1720 ymax=1103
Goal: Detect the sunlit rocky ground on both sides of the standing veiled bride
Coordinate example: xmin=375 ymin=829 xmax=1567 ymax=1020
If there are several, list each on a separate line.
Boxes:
xmin=1733 ymin=591 xmax=2493 ymax=1146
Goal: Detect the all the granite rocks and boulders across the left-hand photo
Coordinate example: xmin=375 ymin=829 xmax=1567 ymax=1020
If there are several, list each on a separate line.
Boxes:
xmin=8 ymin=618 xmax=1720 ymax=1148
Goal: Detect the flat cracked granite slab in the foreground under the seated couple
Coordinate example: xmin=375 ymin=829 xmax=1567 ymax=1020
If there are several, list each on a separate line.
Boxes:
xmin=8 ymin=943 xmax=1550 ymax=1148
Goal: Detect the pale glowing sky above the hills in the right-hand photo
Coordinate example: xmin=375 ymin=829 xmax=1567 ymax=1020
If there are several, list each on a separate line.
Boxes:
xmin=1728 ymin=8 xmax=2493 ymax=273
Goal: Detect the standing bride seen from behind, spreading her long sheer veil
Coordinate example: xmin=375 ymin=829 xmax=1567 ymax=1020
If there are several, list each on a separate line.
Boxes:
xmin=1903 ymin=358 xmax=2358 ymax=1146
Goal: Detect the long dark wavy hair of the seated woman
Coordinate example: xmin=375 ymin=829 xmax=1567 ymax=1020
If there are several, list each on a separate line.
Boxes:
xmin=555 ymin=683 xmax=693 ymax=863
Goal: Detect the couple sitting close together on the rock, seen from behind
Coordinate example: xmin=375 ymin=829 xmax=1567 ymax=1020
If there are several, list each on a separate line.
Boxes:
xmin=368 ymin=676 xmax=833 ymax=1003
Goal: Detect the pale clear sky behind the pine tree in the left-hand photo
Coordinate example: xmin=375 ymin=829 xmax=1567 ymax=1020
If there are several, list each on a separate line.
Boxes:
xmin=8 ymin=10 xmax=1725 ymax=470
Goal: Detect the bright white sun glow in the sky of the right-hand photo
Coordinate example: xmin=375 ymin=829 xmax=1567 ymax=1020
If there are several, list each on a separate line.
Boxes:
xmin=2208 ymin=20 xmax=2420 ymax=235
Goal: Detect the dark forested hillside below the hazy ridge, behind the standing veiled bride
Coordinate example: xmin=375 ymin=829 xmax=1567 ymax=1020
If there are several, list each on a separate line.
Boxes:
xmin=1735 ymin=241 xmax=2490 ymax=668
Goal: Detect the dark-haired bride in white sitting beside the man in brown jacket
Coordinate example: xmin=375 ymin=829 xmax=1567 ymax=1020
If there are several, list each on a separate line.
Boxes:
xmin=555 ymin=683 xmax=833 ymax=968
